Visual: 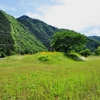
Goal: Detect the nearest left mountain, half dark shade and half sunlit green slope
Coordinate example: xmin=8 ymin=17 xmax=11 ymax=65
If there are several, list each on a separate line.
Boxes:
xmin=0 ymin=11 xmax=47 ymax=55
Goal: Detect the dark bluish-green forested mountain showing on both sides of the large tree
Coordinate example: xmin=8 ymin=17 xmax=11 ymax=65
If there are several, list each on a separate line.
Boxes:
xmin=17 ymin=15 xmax=100 ymax=52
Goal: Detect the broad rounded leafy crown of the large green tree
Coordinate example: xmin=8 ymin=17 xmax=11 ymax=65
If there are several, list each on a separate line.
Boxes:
xmin=51 ymin=30 xmax=87 ymax=53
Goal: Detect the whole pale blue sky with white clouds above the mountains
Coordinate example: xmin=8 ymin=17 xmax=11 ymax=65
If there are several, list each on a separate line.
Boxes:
xmin=0 ymin=0 xmax=100 ymax=36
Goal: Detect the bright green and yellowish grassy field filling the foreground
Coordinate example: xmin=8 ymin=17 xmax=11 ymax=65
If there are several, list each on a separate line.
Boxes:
xmin=0 ymin=52 xmax=100 ymax=100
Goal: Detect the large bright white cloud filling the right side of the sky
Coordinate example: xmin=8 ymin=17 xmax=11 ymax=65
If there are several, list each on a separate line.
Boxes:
xmin=27 ymin=0 xmax=100 ymax=35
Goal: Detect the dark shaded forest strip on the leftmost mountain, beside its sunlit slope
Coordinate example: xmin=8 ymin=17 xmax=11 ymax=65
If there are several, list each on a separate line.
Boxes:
xmin=0 ymin=11 xmax=14 ymax=56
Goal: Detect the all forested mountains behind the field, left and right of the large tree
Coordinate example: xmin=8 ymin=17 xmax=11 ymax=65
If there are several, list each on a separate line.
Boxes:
xmin=0 ymin=10 xmax=100 ymax=57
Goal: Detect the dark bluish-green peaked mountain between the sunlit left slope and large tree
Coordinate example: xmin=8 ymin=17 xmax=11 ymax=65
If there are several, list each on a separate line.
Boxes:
xmin=17 ymin=15 xmax=59 ymax=49
